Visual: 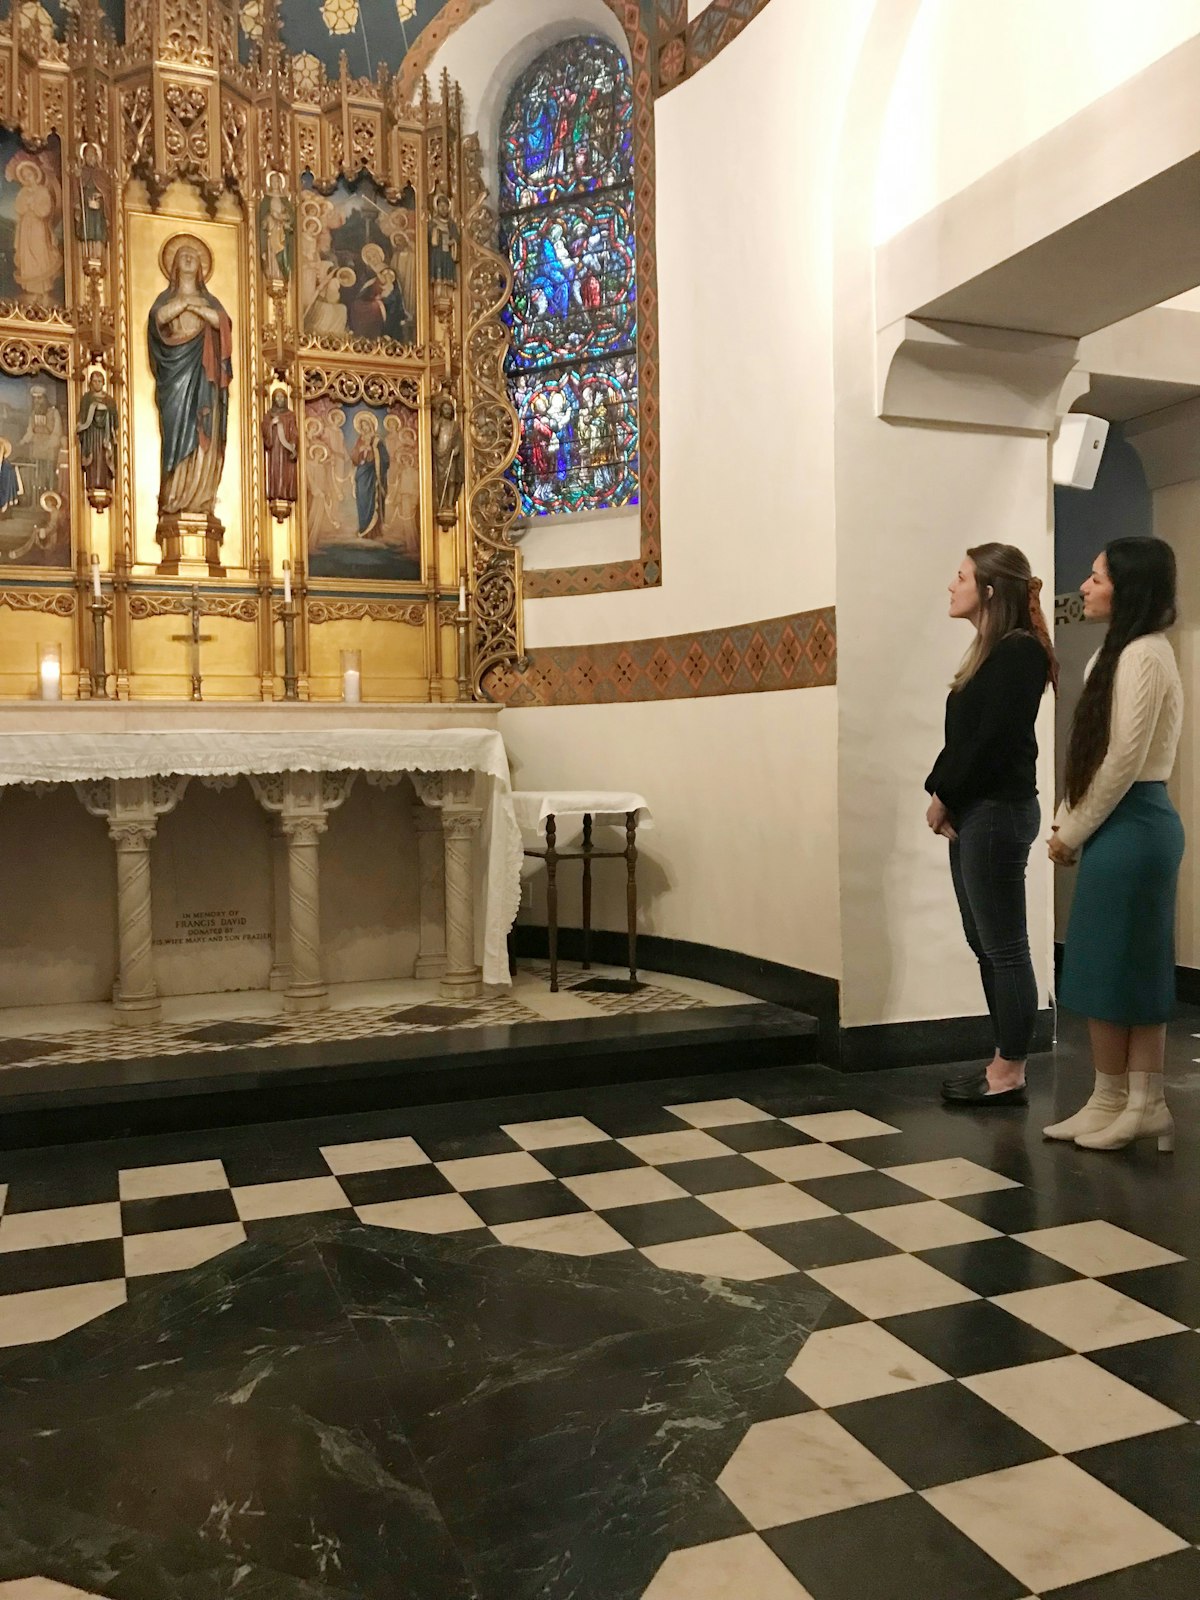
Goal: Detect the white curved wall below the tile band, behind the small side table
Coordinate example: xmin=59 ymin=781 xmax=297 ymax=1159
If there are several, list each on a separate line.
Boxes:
xmin=502 ymin=688 xmax=838 ymax=976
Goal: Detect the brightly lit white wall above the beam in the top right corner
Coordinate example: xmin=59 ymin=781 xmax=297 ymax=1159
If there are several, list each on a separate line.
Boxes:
xmin=876 ymin=0 xmax=1200 ymax=240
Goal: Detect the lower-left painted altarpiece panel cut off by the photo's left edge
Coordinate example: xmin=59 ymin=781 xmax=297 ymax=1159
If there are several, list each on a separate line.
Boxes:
xmin=0 ymin=376 xmax=70 ymax=566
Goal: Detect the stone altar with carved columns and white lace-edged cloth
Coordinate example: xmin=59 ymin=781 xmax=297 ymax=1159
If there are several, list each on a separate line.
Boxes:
xmin=0 ymin=701 xmax=522 ymax=1022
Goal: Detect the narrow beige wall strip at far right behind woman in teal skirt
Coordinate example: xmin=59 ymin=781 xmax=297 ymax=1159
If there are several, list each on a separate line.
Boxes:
xmin=1154 ymin=478 xmax=1200 ymax=966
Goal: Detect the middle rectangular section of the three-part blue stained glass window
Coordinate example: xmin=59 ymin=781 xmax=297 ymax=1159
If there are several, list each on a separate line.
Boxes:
xmin=507 ymin=200 xmax=637 ymax=366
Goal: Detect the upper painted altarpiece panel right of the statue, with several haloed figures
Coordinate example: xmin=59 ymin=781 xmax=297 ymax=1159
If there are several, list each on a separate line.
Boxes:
xmin=299 ymin=176 xmax=418 ymax=344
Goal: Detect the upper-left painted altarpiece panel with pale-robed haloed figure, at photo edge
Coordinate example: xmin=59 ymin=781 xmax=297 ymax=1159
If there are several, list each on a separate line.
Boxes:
xmin=0 ymin=133 xmax=64 ymax=306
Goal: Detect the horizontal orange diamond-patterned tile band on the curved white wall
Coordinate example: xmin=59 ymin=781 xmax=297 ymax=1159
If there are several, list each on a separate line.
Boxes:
xmin=485 ymin=606 xmax=837 ymax=707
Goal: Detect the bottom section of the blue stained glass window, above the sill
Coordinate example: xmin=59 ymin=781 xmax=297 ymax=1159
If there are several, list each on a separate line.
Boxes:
xmin=510 ymin=357 xmax=638 ymax=517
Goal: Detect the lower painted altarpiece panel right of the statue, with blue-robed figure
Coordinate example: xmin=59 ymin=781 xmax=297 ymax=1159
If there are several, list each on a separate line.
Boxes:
xmin=304 ymin=398 xmax=421 ymax=582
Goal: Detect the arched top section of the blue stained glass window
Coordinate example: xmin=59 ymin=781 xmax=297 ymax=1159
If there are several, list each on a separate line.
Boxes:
xmin=501 ymin=38 xmax=634 ymax=211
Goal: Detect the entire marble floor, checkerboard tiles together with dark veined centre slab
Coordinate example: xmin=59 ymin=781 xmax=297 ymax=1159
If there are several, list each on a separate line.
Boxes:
xmin=0 ymin=1021 xmax=1200 ymax=1600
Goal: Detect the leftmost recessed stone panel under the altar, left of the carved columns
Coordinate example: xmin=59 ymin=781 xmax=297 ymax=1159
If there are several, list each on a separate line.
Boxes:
xmin=0 ymin=784 xmax=117 ymax=1004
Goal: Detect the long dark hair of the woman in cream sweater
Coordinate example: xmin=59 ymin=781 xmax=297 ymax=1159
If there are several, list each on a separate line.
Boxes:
xmin=1066 ymin=539 xmax=1174 ymax=805
